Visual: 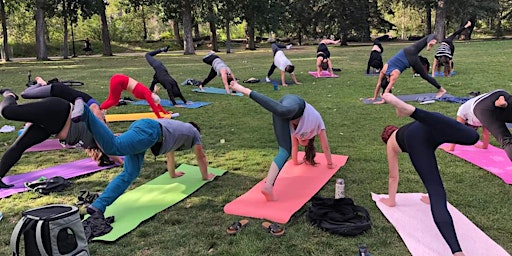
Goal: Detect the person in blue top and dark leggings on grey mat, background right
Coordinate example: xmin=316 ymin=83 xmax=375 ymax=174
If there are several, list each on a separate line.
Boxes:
xmin=371 ymin=34 xmax=446 ymax=104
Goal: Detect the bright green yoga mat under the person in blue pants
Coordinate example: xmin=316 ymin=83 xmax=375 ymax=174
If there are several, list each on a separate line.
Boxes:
xmin=93 ymin=164 xmax=226 ymax=242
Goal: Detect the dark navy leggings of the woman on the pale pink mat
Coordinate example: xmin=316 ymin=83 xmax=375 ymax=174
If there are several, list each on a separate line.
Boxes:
xmin=405 ymin=108 xmax=479 ymax=253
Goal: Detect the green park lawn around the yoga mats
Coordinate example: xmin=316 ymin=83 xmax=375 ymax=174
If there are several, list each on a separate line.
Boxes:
xmin=0 ymin=41 xmax=512 ymax=255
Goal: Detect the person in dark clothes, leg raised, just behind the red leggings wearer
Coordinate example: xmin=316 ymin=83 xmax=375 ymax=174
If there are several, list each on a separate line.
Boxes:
xmin=145 ymin=49 xmax=187 ymax=105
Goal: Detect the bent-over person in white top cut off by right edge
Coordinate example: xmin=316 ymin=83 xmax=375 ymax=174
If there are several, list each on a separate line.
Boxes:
xmin=448 ymin=89 xmax=512 ymax=161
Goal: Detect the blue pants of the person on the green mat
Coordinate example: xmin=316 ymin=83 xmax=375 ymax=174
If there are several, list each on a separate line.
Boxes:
xmin=83 ymin=106 xmax=162 ymax=212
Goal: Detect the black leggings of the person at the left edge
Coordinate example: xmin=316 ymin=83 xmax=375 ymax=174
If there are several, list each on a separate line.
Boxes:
xmin=0 ymin=96 xmax=71 ymax=178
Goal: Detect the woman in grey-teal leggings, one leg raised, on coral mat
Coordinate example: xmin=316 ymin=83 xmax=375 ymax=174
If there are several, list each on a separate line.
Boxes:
xmin=230 ymin=81 xmax=335 ymax=201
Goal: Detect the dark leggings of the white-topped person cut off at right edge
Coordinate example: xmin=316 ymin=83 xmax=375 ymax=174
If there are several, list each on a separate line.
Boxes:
xmin=473 ymin=90 xmax=512 ymax=161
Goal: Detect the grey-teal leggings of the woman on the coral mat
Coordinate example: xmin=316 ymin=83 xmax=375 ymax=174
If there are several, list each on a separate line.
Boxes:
xmin=249 ymin=91 xmax=306 ymax=183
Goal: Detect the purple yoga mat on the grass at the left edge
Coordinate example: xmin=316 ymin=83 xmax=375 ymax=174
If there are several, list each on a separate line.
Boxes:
xmin=0 ymin=158 xmax=118 ymax=198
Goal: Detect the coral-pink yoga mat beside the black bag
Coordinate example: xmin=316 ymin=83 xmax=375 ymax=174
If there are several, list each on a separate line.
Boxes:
xmin=224 ymin=152 xmax=348 ymax=224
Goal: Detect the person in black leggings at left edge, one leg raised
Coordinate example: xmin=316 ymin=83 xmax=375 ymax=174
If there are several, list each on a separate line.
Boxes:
xmin=0 ymin=89 xmax=112 ymax=188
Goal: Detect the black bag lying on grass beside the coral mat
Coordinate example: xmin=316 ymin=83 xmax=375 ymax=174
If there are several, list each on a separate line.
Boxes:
xmin=306 ymin=196 xmax=372 ymax=236
